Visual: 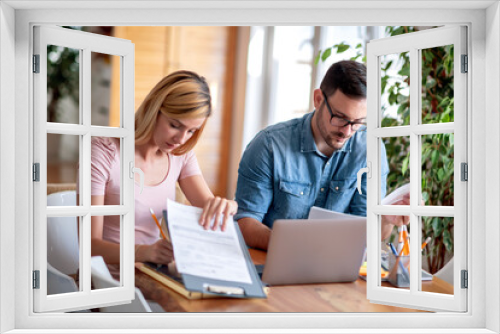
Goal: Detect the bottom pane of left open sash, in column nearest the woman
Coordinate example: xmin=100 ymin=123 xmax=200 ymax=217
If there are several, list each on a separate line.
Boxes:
xmin=92 ymin=216 xmax=121 ymax=290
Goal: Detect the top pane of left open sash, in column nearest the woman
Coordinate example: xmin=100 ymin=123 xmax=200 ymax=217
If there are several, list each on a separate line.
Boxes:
xmin=91 ymin=52 xmax=121 ymax=127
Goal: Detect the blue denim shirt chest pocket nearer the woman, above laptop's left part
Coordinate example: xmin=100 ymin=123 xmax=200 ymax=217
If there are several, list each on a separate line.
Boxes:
xmin=275 ymin=180 xmax=311 ymax=219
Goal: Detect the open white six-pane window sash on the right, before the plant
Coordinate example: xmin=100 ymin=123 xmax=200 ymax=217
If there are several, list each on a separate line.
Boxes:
xmin=367 ymin=25 xmax=469 ymax=312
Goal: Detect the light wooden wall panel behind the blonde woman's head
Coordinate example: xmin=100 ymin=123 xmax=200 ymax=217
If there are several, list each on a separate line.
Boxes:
xmin=111 ymin=27 xmax=236 ymax=196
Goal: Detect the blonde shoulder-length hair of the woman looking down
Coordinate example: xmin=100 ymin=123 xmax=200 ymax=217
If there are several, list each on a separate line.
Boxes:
xmin=135 ymin=71 xmax=212 ymax=155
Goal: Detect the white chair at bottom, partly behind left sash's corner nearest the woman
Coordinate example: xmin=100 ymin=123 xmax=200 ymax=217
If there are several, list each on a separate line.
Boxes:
xmin=91 ymin=256 xmax=156 ymax=313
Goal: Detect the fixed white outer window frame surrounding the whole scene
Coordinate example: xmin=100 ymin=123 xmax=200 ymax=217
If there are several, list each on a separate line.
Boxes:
xmin=0 ymin=1 xmax=500 ymax=333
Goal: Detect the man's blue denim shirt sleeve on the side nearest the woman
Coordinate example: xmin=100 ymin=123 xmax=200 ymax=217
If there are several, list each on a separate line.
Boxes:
xmin=235 ymin=130 xmax=274 ymax=222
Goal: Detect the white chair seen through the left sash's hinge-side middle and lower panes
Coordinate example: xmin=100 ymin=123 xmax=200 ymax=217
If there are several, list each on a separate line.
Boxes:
xmin=47 ymin=190 xmax=80 ymax=275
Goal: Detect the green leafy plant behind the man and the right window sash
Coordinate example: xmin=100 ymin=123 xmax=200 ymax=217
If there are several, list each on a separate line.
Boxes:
xmin=315 ymin=26 xmax=454 ymax=273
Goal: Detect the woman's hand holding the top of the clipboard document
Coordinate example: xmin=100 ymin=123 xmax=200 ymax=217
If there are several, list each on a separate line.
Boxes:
xmin=199 ymin=196 xmax=238 ymax=231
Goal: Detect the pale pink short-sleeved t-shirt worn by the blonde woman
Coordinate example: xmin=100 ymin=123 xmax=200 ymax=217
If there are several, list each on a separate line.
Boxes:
xmin=91 ymin=137 xmax=201 ymax=274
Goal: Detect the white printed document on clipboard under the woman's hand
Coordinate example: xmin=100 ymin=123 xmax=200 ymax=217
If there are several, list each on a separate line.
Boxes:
xmin=167 ymin=199 xmax=252 ymax=284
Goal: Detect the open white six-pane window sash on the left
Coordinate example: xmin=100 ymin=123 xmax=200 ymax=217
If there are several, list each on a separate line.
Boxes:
xmin=33 ymin=26 xmax=135 ymax=312
